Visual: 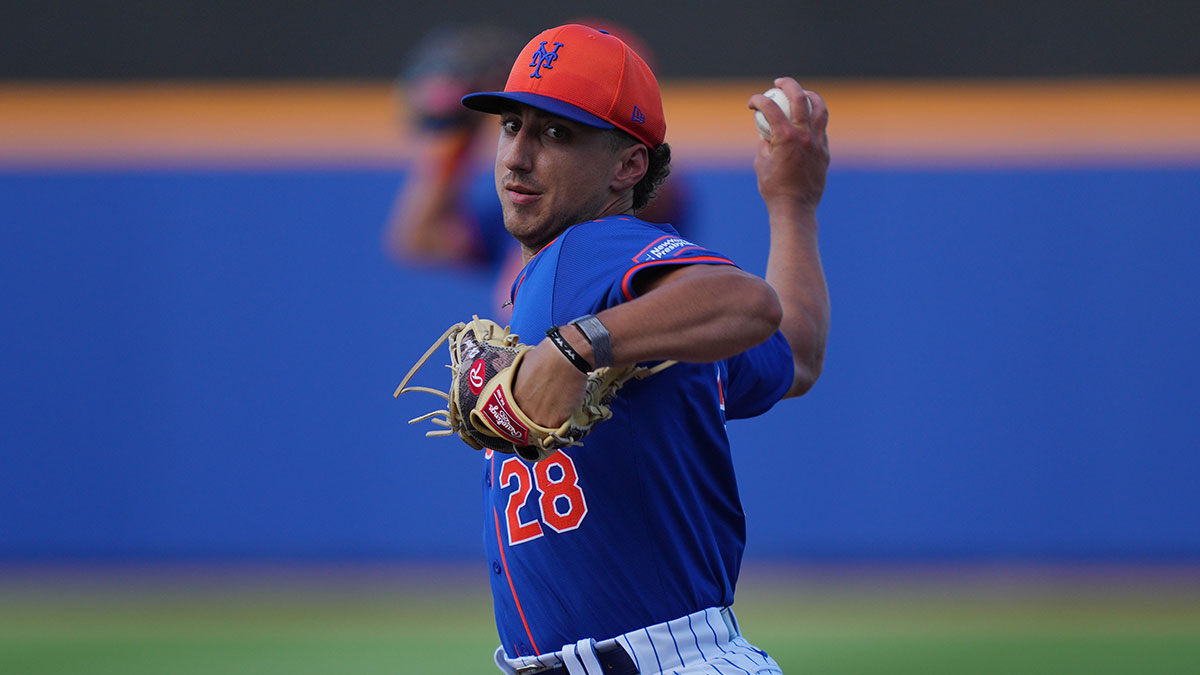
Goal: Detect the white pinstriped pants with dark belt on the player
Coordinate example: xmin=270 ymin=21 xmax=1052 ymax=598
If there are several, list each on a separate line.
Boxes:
xmin=496 ymin=607 xmax=782 ymax=675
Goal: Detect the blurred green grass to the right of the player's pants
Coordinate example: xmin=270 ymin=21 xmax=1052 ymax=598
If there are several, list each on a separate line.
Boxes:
xmin=738 ymin=571 xmax=1200 ymax=675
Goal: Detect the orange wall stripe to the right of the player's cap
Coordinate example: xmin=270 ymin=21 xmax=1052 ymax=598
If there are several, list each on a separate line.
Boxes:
xmin=666 ymin=79 xmax=1200 ymax=165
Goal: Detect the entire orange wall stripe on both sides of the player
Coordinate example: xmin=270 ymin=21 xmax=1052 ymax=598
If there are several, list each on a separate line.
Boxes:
xmin=0 ymin=79 xmax=1200 ymax=167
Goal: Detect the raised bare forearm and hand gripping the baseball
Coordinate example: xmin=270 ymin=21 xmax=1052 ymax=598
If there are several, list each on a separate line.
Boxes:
xmin=749 ymin=78 xmax=829 ymax=396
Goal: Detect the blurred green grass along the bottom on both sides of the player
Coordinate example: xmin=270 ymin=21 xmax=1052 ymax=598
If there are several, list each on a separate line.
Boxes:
xmin=0 ymin=568 xmax=1200 ymax=675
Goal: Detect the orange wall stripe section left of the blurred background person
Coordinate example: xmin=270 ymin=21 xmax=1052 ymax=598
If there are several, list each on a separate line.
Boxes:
xmin=0 ymin=83 xmax=406 ymax=163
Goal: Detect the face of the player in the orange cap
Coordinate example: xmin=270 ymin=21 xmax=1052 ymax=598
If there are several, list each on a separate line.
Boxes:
xmin=496 ymin=106 xmax=625 ymax=253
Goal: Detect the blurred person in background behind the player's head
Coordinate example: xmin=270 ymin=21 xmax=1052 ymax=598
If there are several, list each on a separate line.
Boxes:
xmin=383 ymin=18 xmax=694 ymax=323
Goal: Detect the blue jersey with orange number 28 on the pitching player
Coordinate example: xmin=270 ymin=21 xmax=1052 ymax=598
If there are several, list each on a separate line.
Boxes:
xmin=484 ymin=216 xmax=793 ymax=657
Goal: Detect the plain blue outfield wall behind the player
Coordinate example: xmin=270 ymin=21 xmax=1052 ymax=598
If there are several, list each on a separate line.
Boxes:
xmin=0 ymin=167 xmax=1200 ymax=561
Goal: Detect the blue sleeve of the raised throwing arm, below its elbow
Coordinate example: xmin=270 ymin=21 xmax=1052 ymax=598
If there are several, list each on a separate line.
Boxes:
xmin=725 ymin=330 xmax=796 ymax=419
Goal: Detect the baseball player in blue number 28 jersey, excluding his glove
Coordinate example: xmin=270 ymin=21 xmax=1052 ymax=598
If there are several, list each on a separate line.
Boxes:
xmin=453 ymin=24 xmax=829 ymax=675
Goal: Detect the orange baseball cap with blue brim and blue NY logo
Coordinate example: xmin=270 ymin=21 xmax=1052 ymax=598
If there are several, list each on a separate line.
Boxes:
xmin=462 ymin=24 xmax=667 ymax=148
